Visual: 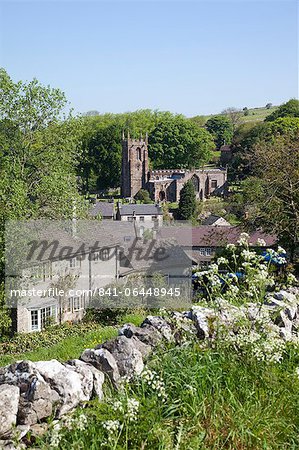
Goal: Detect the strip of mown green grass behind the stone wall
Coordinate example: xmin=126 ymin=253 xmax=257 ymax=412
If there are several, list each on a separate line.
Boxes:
xmin=0 ymin=312 xmax=144 ymax=366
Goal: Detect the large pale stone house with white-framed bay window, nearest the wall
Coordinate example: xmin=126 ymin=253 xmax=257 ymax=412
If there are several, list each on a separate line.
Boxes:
xmin=6 ymin=221 xmax=119 ymax=332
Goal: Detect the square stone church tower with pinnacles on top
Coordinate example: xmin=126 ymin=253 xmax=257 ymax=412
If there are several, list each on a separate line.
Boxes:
xmin=121 ymin=133 xmax=148 ymax=197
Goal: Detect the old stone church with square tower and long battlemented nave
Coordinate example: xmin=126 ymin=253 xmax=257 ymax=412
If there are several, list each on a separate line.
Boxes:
xmin=121 ymin=136 xmax=227 ymax=202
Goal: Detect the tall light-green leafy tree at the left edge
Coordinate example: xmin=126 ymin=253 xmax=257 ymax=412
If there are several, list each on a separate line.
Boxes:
xmin=0 ymin=69 xmax=83 ymax=331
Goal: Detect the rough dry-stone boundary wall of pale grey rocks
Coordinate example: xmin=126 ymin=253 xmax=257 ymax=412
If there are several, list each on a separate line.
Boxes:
xmin=0 ymin=288 xmax=299 ymax=449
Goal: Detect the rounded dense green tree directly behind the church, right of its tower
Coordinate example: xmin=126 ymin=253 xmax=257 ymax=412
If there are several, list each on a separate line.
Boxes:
xmin=149 ymin=115 xmax=214 ymax=169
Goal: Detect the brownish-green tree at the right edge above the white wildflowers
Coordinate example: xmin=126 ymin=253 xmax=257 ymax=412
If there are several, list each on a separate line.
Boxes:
xmin=243 ymin=133 xmax=299 ymax=260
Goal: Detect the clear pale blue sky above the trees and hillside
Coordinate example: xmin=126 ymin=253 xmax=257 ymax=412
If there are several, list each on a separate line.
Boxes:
xmin=0 ymin=0 xmax=298 ymax=116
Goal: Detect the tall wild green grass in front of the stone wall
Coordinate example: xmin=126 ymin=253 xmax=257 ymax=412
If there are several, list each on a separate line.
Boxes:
xmin=39 ymin=344 xmax=299 ymax=450
